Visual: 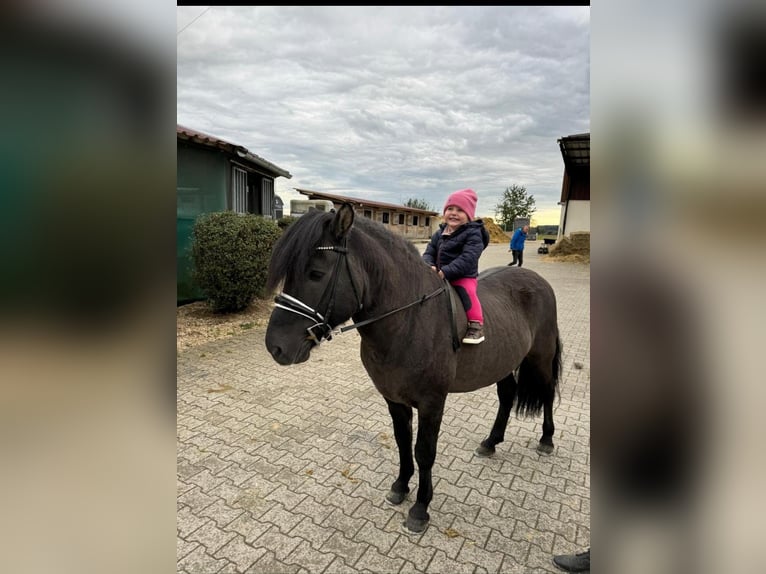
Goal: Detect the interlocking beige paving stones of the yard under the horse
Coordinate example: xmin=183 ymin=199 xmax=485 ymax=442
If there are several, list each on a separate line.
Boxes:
xmin=177 ymin=242 xmax=590 ymax=574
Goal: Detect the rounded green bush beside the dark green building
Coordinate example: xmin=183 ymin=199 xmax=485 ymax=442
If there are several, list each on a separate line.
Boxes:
xmin=192 ymin=211 xmax=281 ymax=313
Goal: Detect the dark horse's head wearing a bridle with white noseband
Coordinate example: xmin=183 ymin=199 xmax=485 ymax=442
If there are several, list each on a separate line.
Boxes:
xmin=266 ymin=204 xmax=362 ymax=365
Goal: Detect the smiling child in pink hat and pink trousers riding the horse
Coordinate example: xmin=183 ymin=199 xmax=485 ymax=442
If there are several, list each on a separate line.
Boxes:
xmin=423 ymin=189 xmax=489 ymax=345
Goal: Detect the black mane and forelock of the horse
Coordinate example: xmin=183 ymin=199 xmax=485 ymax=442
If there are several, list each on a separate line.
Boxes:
xmin=266 ymin=210 xmax=422 ymax=292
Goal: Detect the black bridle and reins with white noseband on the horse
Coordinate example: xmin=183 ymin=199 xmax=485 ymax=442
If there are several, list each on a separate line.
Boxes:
xmin=274 ymin=238 xmax=452 ymax=348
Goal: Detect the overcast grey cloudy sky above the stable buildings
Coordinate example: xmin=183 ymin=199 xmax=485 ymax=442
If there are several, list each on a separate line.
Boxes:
xmin=177 ymin=6 xmax=590 ymax=224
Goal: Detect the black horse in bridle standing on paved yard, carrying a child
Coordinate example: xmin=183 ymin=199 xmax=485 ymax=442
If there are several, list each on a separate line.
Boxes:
xmin=266 ymin=204 xmax=561 ymax=532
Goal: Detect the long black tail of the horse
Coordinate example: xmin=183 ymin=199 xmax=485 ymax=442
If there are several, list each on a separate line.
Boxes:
xmin=516 ymin=332 xmax=563 ymax=417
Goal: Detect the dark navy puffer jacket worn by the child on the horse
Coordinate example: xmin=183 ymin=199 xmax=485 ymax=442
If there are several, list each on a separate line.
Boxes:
xmin=423 ymin=219 xmax=489 ymax=281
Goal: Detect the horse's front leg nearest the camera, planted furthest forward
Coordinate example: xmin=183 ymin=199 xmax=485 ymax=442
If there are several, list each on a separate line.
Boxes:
xmin=406 ymin=398 xmax=444 ymax=532
